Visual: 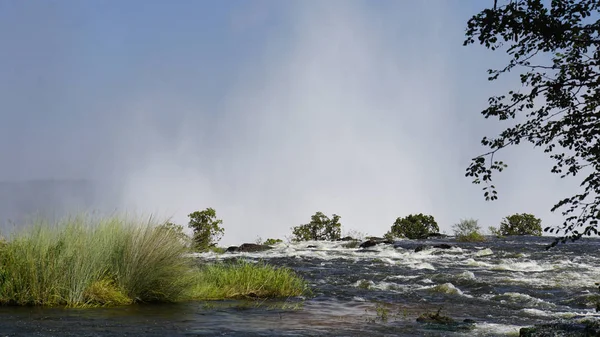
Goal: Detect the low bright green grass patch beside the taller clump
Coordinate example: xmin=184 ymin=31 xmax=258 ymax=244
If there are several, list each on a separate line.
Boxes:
xmin=190 ymin=260 xmax=308 ymax=300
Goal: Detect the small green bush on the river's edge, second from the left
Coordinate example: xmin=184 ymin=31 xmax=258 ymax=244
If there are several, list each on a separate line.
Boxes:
xmin=292 ymin=212 xmax=342 ymax=241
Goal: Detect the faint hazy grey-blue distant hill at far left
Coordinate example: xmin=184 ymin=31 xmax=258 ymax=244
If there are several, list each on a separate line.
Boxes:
xmin=0 ymin=180 xmax=96 ymax=229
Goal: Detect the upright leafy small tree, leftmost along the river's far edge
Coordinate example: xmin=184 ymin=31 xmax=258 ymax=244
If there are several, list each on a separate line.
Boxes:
xmin=188 ymin=208 xmax=225 ymax=251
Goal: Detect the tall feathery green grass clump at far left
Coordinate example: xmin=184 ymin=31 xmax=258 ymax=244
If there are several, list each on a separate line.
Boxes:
xmin=0 ymin=216 xmax=193 ymax=306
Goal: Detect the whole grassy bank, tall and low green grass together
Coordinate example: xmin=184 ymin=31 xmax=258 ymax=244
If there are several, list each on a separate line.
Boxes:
xmin=0 ymin=216 xmax=307 ymax=307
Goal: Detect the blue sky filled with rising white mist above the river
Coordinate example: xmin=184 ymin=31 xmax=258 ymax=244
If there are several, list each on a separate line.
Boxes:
xmin=0 ymin=0 xmax=576 ymax=244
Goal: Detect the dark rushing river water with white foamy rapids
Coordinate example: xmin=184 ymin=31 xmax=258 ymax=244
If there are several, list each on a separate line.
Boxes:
xmin=0 ymin=237 xmax=600 ymax=336
